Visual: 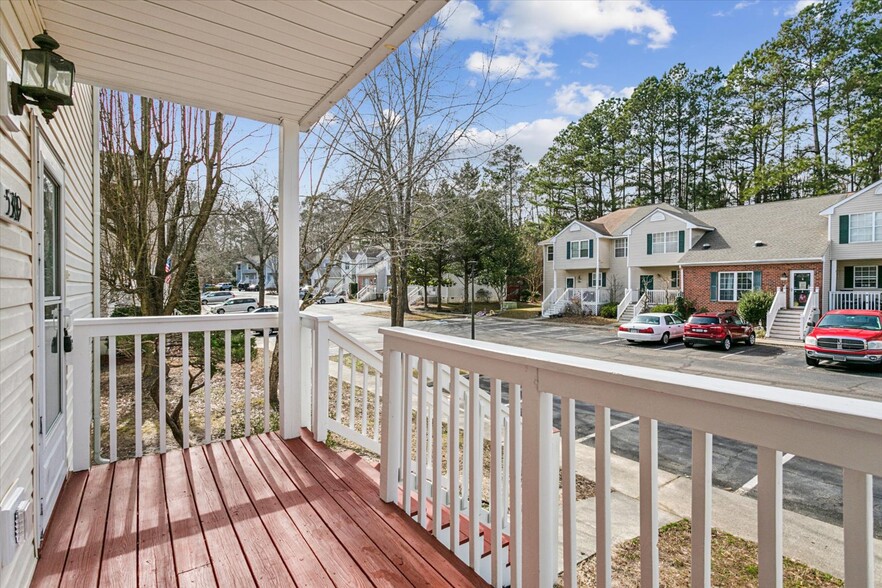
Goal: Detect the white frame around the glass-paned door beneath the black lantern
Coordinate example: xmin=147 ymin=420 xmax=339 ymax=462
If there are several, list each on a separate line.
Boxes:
xmin=31 ymin=130 xmax=70 ymax=537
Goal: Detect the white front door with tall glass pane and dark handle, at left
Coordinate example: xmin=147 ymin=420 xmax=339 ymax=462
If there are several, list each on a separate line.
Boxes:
xmin=34 ymin=137 xmax=67 ymax=534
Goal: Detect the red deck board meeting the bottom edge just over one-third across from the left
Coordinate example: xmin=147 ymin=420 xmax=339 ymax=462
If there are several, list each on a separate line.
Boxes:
xmin=223 ymin=439 xmax=332 ymax=588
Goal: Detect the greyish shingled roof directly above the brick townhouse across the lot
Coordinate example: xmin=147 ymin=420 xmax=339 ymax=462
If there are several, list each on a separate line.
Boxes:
xmin=680 ymin=194 xmax=845 ymax=265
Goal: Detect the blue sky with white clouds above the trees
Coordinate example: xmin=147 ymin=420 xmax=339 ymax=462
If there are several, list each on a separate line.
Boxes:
xmin=238 ymin=0 xmax=816 ymax=191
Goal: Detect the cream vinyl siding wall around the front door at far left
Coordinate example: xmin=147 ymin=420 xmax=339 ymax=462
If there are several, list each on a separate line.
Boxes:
xmin=0 ymin=0 xmax=94 ymax=586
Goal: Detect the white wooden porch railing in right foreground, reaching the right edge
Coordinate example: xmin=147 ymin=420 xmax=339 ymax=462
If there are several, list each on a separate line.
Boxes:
xmin=381 ymin=329 xmax=882 ymax=587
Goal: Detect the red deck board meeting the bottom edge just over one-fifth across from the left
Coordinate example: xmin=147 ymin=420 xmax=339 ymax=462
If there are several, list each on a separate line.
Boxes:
xmin=162 ymin=451 xmax=216 ymax=586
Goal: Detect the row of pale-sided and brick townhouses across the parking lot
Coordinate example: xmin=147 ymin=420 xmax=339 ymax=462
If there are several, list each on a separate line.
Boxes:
xmin=539 ymin=182 xmax=882 ymax=338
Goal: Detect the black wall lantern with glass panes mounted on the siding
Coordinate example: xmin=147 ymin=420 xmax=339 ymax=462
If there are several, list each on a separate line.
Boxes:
xmin=9 ymin=31 xmax=76 ymax=121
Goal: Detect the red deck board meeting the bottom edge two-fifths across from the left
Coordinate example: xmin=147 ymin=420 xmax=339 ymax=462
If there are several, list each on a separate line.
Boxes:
xmin=243 ymin=437 xmax=373 ymax=588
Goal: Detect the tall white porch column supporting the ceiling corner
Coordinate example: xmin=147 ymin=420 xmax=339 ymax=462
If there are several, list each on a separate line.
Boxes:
xmin=277 ymin=120 xmax=303 ymax=439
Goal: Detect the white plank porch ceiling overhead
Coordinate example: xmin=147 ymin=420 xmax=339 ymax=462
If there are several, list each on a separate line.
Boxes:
xmin=36 ymin=0 xmax=446 ymax=130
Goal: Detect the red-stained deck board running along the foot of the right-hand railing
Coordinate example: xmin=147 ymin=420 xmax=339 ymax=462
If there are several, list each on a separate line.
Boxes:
xmin=296 ymin=429 xmax=484 ymax=585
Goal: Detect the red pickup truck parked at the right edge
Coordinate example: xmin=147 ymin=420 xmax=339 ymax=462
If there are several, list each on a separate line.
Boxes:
xmin=805 ymin=310 xmax=882 ymax=366
